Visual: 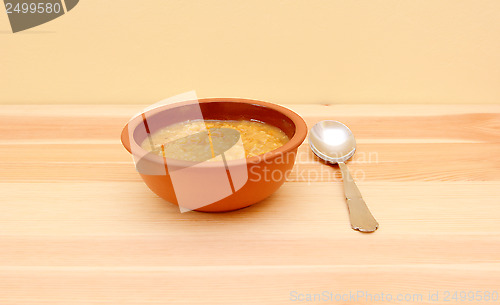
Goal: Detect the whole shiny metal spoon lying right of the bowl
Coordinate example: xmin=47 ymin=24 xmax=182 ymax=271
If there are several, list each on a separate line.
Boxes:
xmin=309 ymin=121 xmax=378 ymax=232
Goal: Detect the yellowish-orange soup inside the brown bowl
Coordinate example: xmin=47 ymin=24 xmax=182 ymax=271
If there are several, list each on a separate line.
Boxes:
xmin=141 ymin=120 xmax=289 ymax=162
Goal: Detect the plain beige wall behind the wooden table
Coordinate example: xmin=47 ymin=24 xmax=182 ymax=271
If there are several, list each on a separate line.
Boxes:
xmin=0 ymin=0 xmax=500 ymax=104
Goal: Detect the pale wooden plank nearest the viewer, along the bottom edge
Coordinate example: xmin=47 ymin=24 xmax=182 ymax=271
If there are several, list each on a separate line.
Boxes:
xmin=0 ymin=264 xmax=500 ymax=305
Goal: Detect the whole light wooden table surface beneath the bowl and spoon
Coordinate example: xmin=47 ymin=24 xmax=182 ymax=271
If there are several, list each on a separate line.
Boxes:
xmin=0 ymin=105 xmax=500 ymax=305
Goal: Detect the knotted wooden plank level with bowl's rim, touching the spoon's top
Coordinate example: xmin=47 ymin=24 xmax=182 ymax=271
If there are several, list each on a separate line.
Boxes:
xmin=0 ymin=112 xmax=500 ymax=144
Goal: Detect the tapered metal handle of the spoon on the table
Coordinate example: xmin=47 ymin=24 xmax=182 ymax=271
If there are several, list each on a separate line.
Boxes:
xmin=338 ymin=162 xmax=378 ymax=232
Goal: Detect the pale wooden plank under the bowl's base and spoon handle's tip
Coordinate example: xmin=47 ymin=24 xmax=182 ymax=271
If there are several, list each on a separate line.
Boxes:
xmin=0 ymin=182 xmax=500 ymax=235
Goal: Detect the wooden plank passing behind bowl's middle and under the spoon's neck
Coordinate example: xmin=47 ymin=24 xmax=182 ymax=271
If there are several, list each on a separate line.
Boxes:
xmin=0 ymin=143 xmax=500 ymax=182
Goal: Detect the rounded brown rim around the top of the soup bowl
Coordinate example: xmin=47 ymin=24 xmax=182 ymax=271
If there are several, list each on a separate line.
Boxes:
xmin=121 ymin=98 xmax=307 ymax=168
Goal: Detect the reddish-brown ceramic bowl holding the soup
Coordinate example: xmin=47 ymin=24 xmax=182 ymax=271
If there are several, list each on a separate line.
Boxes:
xmin=121 ymin=98 xmax=307 ymax=212
